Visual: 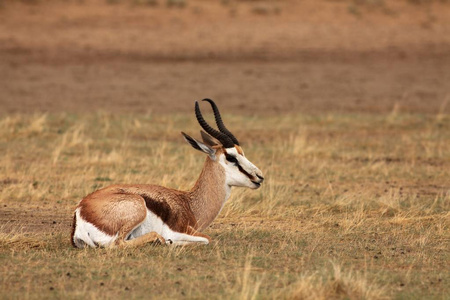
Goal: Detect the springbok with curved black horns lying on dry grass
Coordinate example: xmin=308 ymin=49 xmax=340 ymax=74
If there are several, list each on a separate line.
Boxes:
xmin=72 ymin=99 xmax=264 ymax=248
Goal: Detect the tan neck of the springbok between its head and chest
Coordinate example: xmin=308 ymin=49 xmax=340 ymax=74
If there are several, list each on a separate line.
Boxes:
xmin=189 ymin=157 xmax=229 ymax=230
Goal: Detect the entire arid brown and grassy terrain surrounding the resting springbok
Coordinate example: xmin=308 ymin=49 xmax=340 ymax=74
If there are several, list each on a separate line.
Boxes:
xmin=0 ymin=0 xmax=450 ymax=299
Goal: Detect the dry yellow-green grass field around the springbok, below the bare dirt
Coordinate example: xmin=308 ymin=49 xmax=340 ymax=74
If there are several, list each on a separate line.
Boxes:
xmin=0 ymin=111 xmax=450 ymax=299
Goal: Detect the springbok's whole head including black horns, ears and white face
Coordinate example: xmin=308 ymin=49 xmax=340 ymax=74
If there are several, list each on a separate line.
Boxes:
xmin=182 ymin=99 xmax=264 ymax=189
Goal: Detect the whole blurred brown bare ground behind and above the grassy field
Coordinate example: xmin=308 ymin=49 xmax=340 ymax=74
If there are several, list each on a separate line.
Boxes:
xmin=0 ymin=0 xmax=450 ymax=114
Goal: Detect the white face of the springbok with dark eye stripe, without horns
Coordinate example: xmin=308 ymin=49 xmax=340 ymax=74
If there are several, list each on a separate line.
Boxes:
xmin=219 ymin=148 xmax=264 ymax=189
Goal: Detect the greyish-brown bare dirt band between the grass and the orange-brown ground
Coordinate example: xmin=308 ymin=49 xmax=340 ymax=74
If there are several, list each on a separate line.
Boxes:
xmin=0 ymin=59 xmax=450 ymax=114
